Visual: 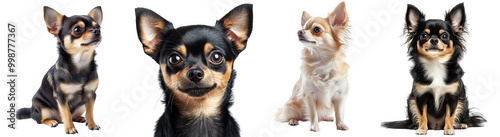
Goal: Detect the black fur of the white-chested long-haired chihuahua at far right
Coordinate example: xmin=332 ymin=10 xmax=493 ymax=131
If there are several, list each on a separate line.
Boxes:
xmin=382 ymin=3 xmax=486 ymax=129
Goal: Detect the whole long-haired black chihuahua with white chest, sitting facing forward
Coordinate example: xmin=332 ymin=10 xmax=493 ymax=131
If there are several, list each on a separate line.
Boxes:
xmin=382 ymin=3 xmax=486 ymax=135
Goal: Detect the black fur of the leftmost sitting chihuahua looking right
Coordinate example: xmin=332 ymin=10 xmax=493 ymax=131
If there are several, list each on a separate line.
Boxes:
xmin=17 ymin=6 xmax=102 ymax=134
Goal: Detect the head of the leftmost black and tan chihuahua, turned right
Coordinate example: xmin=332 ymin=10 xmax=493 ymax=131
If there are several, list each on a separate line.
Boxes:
xmin=43 ymin=6 xmax=102 ymax=54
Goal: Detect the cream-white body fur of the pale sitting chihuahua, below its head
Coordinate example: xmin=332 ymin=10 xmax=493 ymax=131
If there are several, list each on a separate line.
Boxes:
xmin=276 ymin=34 xmax=349 ymax=131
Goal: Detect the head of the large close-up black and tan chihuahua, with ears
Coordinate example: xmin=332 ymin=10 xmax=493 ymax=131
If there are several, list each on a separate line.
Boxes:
xmin=135 ymin=4 xmax=252 ymax=99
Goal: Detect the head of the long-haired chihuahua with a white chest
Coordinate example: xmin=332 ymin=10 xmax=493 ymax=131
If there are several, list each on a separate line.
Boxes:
xmin=405 ymin=3 xmax=466 ymax=60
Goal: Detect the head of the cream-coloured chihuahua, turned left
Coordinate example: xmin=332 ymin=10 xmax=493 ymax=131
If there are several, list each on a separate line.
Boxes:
xmin=298 ymin=2 xmax=348 ymax=48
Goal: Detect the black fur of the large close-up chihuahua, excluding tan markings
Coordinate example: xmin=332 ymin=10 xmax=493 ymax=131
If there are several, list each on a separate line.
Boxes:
xmin=136 ymin=4 xmax=253 ymax=137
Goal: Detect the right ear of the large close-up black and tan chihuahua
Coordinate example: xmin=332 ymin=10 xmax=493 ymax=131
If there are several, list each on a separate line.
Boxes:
xmin=215 ymin=4 xmax=253 ymax=55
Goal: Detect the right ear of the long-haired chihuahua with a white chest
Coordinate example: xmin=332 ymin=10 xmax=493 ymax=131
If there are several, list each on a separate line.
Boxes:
xmin=445 ymin=3 xmax=465 ymax=34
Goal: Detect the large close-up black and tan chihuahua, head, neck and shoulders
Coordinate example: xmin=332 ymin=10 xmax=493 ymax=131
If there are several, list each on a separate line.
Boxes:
xmin=135 ymin=4 xmax=253 ymax=137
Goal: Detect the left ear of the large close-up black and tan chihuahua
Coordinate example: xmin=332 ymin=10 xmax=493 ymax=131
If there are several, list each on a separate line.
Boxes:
xmin=135 ymin=8 xmax=174 ymax=62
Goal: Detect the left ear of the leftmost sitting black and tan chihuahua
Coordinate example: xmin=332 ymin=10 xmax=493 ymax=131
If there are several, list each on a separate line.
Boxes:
xmin=43 ymin=6 xmax=64 ymax=35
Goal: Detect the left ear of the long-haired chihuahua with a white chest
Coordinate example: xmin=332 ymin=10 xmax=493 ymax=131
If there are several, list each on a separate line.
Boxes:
xmin=405 ymin=4 xmax=425 ymax=33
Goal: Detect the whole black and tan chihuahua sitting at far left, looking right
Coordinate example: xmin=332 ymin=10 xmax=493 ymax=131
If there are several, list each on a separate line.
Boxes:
xmin=17 ymin=6 xmax=102 ymax=134
